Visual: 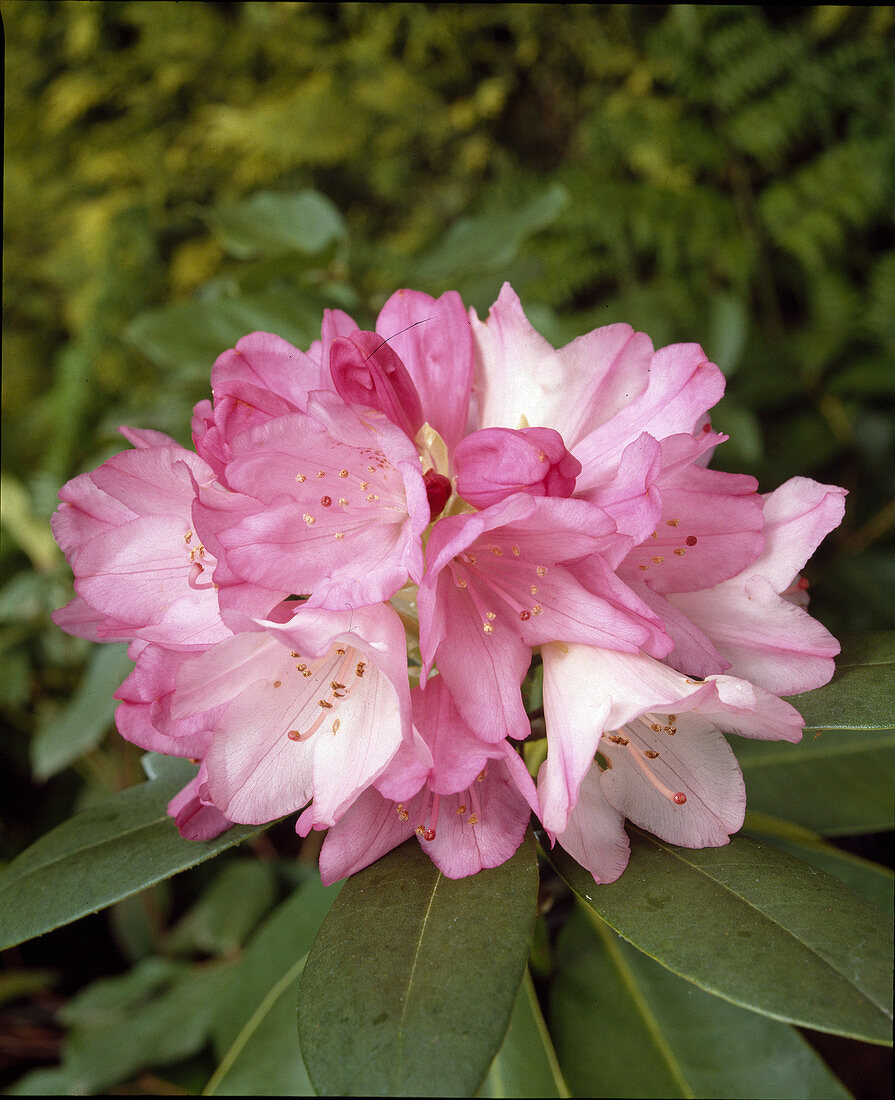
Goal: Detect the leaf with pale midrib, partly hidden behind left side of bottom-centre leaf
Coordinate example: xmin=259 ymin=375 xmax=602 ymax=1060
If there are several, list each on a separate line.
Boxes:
xmin=203 ymin=871 xmax=340 ymax=1096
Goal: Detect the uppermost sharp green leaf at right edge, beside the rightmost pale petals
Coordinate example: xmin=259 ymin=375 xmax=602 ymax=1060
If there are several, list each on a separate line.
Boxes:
xmin=789 ymin=630 xmax=895 ymax=729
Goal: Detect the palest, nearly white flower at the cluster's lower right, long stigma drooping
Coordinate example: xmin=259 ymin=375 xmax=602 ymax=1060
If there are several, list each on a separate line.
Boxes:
xmin=538 ymin=644 xmax=803 ymax=882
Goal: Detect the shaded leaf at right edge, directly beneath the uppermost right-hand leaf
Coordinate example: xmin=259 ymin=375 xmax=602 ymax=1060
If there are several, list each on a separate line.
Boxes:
xmin=730 ymin=729 xmax=895 ymax=836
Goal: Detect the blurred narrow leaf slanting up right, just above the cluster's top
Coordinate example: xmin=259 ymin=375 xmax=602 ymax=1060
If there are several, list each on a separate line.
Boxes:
xmin=413 ymin=183 xmax=568 ymax=286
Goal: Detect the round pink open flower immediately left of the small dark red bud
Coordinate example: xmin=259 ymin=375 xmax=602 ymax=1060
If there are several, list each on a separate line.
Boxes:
xmin=194 ymin=392 xmax=429 ymax=608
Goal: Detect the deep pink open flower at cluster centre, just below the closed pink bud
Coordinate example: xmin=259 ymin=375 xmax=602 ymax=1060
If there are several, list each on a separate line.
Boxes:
xmin=418 ymin=493 xmax=667 ymax=741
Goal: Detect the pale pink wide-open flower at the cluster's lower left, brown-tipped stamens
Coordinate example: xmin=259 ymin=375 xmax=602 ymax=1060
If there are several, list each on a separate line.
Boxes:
xmin=172 ymin=604 xmax=410 ymax=827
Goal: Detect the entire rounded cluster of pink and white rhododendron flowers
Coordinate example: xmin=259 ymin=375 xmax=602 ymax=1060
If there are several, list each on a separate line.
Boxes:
xmin=53 ymin=285 xmax=844 ymax=882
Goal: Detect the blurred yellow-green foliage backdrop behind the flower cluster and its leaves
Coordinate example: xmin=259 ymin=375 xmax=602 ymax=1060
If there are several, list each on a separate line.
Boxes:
xmin=0 ymin=0 xmax=895 ymax=1096
